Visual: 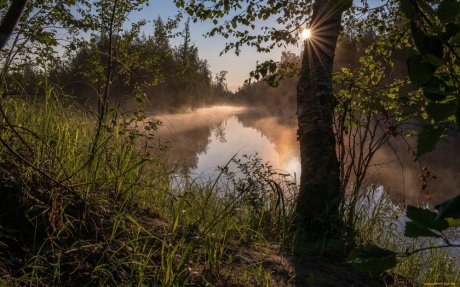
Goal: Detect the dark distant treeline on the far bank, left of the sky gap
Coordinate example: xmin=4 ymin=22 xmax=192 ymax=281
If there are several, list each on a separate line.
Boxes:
xmin=6 ymin=17 xmax=232 ymax=111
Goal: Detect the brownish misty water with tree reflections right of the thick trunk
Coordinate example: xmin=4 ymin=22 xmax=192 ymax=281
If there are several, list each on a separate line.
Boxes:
xmin=368 ymin=137 xmax=460 ymax=204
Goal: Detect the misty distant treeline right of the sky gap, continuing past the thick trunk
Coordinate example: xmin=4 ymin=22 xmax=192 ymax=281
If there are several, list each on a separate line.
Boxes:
xmin=234 ymin=29 xmax=413 ymax=116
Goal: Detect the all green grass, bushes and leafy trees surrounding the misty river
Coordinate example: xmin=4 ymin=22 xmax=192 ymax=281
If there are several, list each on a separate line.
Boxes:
xmin=0 ymin=0 xmax=460 ymax=286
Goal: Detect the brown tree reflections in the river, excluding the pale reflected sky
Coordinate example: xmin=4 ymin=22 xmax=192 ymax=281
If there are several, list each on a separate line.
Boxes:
xmin=152 ymin=108 xmax=460 ymax=206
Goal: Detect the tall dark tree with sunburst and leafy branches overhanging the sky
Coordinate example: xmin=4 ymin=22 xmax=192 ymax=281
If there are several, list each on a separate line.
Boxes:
xmin=175 ymin=0 xmax=352 ymax=250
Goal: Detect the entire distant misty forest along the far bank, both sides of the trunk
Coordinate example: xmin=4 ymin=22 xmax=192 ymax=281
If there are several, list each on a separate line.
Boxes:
xmin=2 ymin=14 xmax=411 ymax=115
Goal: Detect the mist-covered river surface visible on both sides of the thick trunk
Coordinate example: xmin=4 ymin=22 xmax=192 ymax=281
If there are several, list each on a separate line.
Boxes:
xmin=155 ymin=106 xmax=460 ymax=205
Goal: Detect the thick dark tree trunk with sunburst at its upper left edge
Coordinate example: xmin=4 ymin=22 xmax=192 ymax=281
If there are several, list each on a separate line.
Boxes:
xmin=296 ymin=0 xmax=343 ymax=248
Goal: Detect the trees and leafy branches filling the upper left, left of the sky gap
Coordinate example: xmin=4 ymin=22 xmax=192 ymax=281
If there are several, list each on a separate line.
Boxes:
xmin=2 ymin=0 xmax=227 ymax=114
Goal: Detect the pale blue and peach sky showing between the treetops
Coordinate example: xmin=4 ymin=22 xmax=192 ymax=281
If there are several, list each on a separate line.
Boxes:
xmin=130 ymin=0 xmax=381 ymax=91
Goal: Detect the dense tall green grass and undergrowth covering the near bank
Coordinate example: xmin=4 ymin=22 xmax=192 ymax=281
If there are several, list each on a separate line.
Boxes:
xmin=0 ymin=87 xmax=459 ymax=286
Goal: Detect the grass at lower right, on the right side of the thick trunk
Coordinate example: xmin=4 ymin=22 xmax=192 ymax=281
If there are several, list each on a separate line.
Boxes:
xmin=350 ymin=186 xmax=460 ymax=286
